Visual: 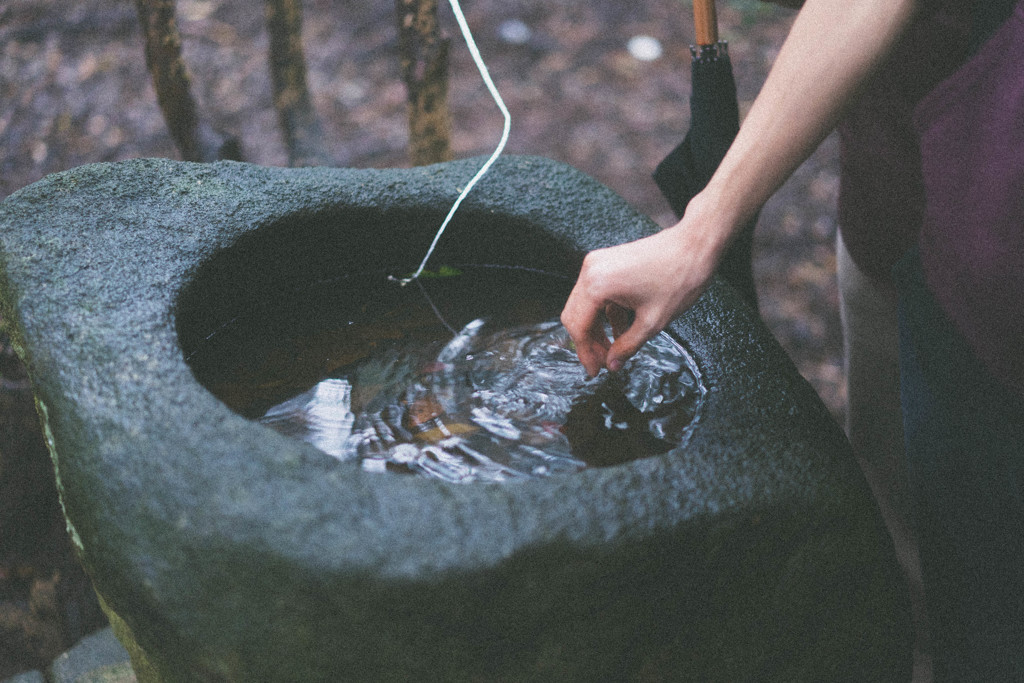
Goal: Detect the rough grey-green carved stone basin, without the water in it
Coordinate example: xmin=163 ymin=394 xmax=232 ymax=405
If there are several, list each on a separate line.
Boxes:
xmin=0 ymin=157 xmax=911 ymax=681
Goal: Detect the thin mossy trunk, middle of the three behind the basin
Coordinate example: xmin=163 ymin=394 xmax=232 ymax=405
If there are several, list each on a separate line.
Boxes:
xmin=264 ymin=0 xmax=331 ymax=166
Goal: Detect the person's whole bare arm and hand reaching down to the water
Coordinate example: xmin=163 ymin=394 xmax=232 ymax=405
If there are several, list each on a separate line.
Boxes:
xmin=562 ymin=0 xmax=916 ymax=375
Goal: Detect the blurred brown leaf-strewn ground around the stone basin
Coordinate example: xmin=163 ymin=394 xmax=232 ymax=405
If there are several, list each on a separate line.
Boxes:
xmin=0 ymin=0 xmax=844 ymax=679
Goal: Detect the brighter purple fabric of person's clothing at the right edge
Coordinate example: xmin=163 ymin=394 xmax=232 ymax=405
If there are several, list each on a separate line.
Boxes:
xmin=914 ymin=0 xmax=1024 ymax=396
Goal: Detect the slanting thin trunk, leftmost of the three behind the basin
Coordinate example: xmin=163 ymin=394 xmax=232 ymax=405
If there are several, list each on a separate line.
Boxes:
xmin=135 ymin=0 xmax=242 ymax=162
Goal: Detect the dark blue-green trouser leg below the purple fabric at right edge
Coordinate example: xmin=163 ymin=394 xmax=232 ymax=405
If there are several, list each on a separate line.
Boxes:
xmin=894 ymin=251 xmax=1024 ymax=682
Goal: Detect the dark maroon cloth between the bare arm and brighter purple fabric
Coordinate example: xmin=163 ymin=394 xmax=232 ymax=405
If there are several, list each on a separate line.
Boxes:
xmin=839 ymin=0 xmax=972 ymax=279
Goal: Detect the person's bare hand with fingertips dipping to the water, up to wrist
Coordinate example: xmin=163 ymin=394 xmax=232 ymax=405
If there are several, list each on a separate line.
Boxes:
xmin=561 ymin=221 xmax=718 ymax=377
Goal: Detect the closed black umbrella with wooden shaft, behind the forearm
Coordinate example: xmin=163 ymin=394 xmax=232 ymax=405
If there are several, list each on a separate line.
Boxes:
xmin=654 ymin=0 xmax=757 ymax=308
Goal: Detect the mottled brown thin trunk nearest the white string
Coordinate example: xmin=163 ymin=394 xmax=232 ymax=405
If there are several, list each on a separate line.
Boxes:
xmin=395 ymin=0 xmax=452 ymax=166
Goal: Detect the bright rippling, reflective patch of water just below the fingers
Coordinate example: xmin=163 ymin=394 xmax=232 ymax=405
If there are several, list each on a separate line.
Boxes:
xmin=260 ymin=318 xmax=697 ymax=482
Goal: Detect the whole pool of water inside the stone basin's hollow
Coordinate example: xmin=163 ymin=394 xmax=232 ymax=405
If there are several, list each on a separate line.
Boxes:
xmin=177 ymin=210 xmax=703 ymax=482
